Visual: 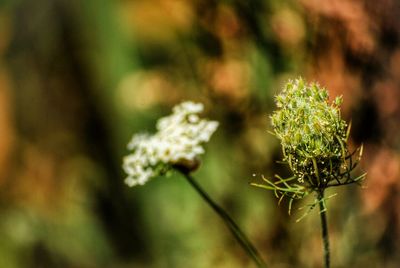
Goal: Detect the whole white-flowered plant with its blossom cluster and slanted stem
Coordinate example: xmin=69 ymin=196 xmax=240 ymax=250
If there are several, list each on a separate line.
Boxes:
xmin=123 ymin=101 xmax=266 ymax=267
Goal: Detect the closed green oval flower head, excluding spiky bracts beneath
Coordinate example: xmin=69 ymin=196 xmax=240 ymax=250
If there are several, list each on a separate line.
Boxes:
xmin=271 ymin=78 xmax=348 ymax=186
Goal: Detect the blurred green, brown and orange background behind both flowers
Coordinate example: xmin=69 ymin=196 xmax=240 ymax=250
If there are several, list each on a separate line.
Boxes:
xmin=0 ymin=0 xmax=400 ymax=268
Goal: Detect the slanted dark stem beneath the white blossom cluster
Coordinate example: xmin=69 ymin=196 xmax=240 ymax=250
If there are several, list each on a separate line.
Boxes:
xmin=182 ymin=172 xmax=267 ymax=268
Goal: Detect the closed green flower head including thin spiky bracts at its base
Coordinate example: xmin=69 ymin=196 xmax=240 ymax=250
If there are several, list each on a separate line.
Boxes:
xmin=253 ymin=78 xmax=365 ymax=214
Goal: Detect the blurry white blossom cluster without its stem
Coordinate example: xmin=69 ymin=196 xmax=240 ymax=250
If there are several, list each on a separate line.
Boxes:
xmin=123 ymin=101 xmax=218 ymax=186
